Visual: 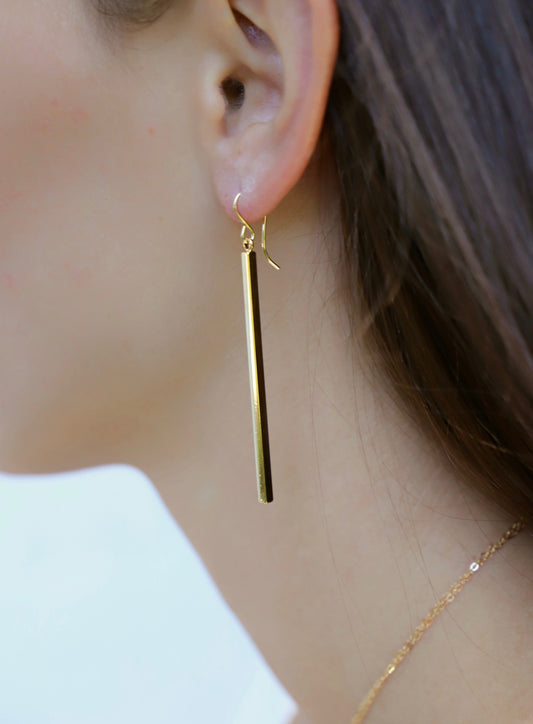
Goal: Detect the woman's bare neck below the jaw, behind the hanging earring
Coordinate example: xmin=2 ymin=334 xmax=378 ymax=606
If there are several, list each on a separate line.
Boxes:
xmin=121 ymin=173 xmax=533 ymax=722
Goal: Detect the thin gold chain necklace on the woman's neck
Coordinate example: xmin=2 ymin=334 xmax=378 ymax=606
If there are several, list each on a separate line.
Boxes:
xmin=352 ymin=520 xmax=525 ymax=724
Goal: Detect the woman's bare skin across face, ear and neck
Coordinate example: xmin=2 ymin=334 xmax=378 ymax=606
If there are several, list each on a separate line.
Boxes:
xmin=0 ymin=0 xmax=533 ymax=724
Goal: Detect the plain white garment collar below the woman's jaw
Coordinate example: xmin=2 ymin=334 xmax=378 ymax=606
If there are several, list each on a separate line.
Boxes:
xmin=0 ymin=465 xmax=297 ymax=724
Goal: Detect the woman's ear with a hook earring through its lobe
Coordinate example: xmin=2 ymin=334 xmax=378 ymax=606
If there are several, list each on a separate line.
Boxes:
xmin=197 ymin=0 xmax=339 ymax=222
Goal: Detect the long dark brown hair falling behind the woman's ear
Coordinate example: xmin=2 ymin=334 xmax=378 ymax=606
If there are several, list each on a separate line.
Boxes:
xmin=325 ymin=0 xmax=533 ymax=521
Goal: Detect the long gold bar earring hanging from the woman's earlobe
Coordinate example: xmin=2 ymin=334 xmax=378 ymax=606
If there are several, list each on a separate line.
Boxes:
xmin=233 ymin=193 xmax=279 ymax=503
